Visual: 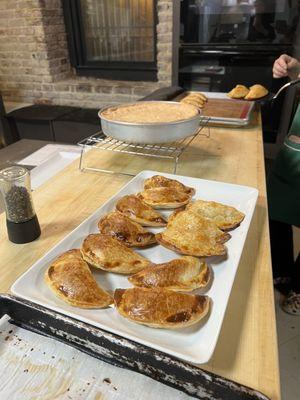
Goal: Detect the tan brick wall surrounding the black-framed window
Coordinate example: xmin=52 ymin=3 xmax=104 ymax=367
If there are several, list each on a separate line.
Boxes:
xmin=0 ymin=0 xmax=173 ymax=108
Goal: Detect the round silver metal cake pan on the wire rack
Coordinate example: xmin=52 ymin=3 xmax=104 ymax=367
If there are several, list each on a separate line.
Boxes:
xmin=98 ymin=101 xmax=201 ymax=144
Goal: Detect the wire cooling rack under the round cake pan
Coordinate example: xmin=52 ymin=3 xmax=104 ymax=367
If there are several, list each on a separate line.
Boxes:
xmin=78 ymin=116 xmax=210 ymax=176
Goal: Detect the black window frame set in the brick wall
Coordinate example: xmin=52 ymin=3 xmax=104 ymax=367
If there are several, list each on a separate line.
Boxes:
xmin=62 ymin=0 xmax=158 ymax=81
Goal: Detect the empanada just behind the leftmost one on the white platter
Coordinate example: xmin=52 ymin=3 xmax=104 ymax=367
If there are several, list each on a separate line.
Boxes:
xmin=81 ymin=233 xmax=150 ymax=274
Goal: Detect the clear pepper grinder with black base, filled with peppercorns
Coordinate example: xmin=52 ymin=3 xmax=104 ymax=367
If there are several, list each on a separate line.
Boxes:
xmin=0 ymin=165 xmax=41 ymax=243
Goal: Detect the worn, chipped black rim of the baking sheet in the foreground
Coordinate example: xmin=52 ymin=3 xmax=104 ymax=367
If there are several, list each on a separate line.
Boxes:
xmin=0 ymin=294 xmax=268 ymax=400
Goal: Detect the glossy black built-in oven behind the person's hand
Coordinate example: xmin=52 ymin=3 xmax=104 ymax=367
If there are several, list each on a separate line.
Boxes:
xmin=179 ymin=0 xmax=300 ymax=141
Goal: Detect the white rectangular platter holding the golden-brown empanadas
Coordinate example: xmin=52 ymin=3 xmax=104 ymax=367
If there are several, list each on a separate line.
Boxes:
xmin=11 ymin=171 xmax=258 ymax=364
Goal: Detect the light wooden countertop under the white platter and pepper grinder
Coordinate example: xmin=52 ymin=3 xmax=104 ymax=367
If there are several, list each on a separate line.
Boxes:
xmin=0 ymin=117 xmax=280 ymax=400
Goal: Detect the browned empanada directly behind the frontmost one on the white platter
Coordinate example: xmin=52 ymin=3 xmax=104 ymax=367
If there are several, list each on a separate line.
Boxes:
xmin=128 ymin=256 xmax=210 ymax=292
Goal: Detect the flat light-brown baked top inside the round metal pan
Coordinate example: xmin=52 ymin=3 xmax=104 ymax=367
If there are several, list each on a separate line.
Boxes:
xmin=100 ymin=101 xmax=199 ymax=124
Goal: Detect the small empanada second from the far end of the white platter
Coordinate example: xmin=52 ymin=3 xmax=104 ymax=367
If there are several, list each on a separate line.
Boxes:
xmin=137 ymin=187 xmax=191 ymax=208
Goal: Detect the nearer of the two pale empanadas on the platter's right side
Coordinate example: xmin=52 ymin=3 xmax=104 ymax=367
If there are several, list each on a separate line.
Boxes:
xmin=156 ymin=210 xmax=230 ymax=257
